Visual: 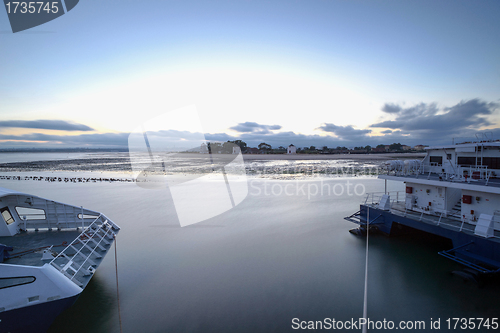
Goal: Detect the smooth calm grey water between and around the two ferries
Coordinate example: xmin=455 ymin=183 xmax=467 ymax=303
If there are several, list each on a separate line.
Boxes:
xmin=0 ymin=152 xmax=500 ymax=333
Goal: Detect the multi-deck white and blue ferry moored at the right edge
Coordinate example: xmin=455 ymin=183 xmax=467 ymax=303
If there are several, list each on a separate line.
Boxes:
xmin=345 ymin=138 xmax=500 ymax=280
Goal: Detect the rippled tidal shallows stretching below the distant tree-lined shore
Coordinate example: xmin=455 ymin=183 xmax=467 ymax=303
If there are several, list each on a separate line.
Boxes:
xmin=0 ymin=152 xmax=391 ymax=180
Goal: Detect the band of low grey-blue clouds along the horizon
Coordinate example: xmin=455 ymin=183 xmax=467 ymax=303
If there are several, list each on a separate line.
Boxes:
xmin=0 ymin=99 xmax=500 ymax=149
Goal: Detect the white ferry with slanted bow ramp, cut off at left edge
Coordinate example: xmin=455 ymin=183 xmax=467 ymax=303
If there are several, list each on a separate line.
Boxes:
xmin=0 ymin=188 xmax=120 ymax=333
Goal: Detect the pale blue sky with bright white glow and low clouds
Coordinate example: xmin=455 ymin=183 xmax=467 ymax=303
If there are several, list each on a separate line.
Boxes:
xmin=0 ymin=0 xmax=500 ymax=149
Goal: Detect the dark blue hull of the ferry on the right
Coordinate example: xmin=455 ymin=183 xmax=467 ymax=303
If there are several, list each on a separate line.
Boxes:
xmin=360 ymin=205 xmax=500 ymax=273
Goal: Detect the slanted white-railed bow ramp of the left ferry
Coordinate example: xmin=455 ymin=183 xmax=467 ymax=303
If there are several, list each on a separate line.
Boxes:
xmin=50 ymin=214 xmax=120 ymax=287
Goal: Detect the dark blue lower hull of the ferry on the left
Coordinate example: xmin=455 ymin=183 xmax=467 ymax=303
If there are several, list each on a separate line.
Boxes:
xmin=0 ymin=295 xmax=79 ymax=333
